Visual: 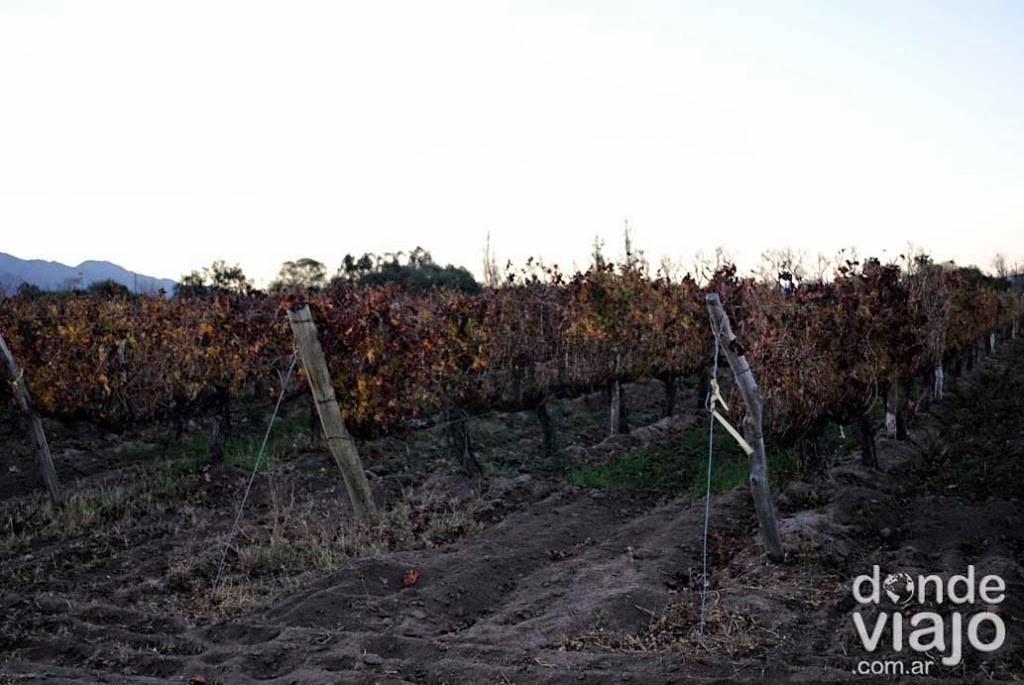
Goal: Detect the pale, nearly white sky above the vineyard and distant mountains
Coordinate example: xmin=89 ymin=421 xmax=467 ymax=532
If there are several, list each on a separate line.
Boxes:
xmin=0 ymin=0 xmax=1024 ymax=285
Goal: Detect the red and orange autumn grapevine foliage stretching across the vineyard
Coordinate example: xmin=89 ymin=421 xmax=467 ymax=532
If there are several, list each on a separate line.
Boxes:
xmin=0 ymin=260 xmax=1024 ymax=462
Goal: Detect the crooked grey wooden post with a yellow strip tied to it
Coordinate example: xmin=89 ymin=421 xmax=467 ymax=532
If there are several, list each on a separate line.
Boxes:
xmin=706 ymin=293 xmax=785 ymax=561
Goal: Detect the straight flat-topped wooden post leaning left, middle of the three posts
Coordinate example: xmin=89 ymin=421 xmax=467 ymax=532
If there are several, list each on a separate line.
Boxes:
xmin=288 ymin=304 xmax=377 ymax=521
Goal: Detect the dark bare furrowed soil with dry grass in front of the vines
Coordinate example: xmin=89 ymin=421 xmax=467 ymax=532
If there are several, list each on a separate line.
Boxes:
xmin=0 ymin=345 xmax=1024 ymax=685
